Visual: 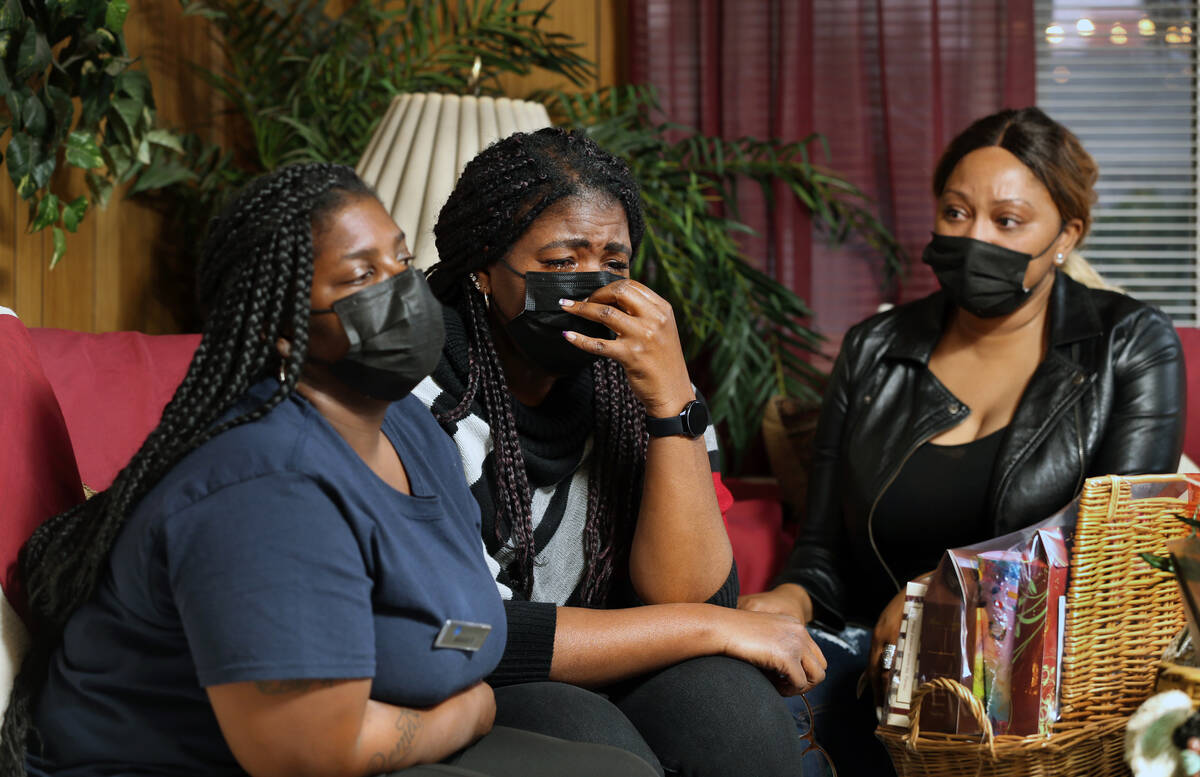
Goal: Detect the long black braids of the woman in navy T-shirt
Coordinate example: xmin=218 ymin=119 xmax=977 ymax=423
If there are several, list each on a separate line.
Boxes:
xmin=0 ymin=164 xmax=374 ymax=775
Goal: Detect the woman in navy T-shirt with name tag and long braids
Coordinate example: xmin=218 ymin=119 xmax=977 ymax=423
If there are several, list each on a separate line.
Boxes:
xmin=0 ymin=164 xmax=653 ymax=777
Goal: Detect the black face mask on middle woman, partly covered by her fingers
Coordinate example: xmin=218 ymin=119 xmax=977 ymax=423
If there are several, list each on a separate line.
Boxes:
xmin=500 ymin=259 xmax=624 ymax=375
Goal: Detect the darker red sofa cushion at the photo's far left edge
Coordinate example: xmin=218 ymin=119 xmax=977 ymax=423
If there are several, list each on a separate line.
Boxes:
xmin=0 ymin=314 xmax=83 ymax=615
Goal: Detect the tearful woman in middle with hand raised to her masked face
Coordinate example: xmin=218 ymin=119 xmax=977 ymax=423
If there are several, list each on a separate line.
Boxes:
xmin=415 ymin=128 xmax=824 ymax=777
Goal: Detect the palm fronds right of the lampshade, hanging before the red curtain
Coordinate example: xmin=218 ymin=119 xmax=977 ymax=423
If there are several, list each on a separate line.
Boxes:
xmin=544 ymin=86 xmax=904 ymax=468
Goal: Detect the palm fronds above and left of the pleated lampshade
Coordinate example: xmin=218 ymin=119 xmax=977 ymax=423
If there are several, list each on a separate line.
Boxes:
xmin=181 ymin=0 xmax=593 ymax=177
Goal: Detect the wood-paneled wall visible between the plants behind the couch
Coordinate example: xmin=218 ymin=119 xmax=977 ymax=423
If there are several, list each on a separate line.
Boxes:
xmin=0 ymin=0 xmax=628 ymax=333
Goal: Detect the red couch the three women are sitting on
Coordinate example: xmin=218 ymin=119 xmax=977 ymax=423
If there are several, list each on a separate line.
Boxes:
xmin=9 ymin=315 xmax=1200 ymax=606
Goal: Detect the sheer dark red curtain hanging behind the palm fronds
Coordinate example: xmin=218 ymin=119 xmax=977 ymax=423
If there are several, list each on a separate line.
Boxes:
xmin=630 ymin=0 xmax=1034 ymax=341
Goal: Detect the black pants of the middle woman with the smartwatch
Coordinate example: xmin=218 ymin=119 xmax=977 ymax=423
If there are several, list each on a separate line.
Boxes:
xmin=496 ymin=656 xmax=805 ymax=777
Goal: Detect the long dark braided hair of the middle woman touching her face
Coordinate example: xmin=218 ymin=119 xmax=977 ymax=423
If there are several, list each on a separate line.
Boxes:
xmin=430 ymin=128 xmax=647 ymax=607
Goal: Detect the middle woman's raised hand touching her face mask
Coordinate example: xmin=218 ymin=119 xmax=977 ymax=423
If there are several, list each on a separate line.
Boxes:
xmin=563 ymin=279 xmax=696 ymax=417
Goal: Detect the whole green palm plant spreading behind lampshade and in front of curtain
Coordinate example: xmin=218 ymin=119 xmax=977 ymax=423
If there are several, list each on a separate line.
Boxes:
xmin=162 ymin=0 xmax=902 ymax=460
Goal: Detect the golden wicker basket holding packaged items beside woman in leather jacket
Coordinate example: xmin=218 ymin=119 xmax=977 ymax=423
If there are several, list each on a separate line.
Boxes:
xmin=876 ymin=475 xmax=1200 ymax=777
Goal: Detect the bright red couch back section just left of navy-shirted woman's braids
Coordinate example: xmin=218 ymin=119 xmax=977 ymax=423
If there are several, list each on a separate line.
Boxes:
xmin=29 ymin=327 xmax=200 ymax=490
